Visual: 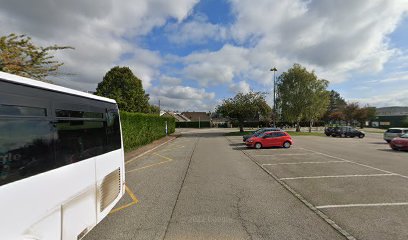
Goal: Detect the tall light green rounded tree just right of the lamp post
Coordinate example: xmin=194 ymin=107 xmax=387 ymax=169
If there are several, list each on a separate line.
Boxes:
xmin=277 ymin=64 xmax=329 ymax=132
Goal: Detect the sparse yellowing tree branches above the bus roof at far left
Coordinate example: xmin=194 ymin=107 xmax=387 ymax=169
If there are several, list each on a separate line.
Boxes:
xmin=0 ymin=33 xmax=73 ymax=82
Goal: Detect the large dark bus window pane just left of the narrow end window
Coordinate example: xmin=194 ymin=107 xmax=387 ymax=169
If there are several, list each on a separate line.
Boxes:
xmin=56 ymin=120 xmax=106 ymax=166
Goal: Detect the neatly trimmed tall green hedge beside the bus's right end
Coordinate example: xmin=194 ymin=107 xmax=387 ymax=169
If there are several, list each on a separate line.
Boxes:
xmin=120 ymin=112 xmax=175 ymax=152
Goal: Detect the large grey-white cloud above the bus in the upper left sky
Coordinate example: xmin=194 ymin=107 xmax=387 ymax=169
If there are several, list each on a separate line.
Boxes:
xmin=0 ymin=0 xmax=198 ymax=90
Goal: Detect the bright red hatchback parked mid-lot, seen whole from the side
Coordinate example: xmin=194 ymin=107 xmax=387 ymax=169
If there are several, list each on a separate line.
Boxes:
xmin=245 ymin=131 xmax=293 ymax=149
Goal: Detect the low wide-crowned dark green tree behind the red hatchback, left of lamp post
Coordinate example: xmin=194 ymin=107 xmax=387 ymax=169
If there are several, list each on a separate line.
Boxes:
xmin=216 ymin=91 xmax=272 ymax=132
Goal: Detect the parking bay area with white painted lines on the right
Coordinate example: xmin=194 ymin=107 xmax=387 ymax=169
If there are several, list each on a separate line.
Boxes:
xmin=229 ymin=135 xmax=408 ymax=239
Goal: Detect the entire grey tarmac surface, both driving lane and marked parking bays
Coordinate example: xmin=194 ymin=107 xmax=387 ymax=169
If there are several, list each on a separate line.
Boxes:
xmin=84 ymin=129 xmax=408 ymax=240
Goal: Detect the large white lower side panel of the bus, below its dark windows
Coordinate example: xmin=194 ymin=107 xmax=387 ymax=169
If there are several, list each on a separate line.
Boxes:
xmin=0 ymin=158 xmax=96 ymax=240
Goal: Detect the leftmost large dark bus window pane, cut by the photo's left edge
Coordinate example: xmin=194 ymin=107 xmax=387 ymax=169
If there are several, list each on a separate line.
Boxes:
xmin=0 ymin=119 xmax=55 ymax=186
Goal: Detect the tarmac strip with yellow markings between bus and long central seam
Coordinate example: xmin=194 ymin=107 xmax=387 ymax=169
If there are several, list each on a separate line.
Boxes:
xmin=85 ymin=137 xmax=197 ymax=240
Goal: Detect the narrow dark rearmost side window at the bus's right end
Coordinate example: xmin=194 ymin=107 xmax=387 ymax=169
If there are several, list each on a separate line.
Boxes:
xmin=106 ymin=110 xmax=122 ymax=152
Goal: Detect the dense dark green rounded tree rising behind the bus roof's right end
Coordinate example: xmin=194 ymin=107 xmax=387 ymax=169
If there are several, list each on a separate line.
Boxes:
xmin=95 ymin=66 xmax=151 ymax=113
